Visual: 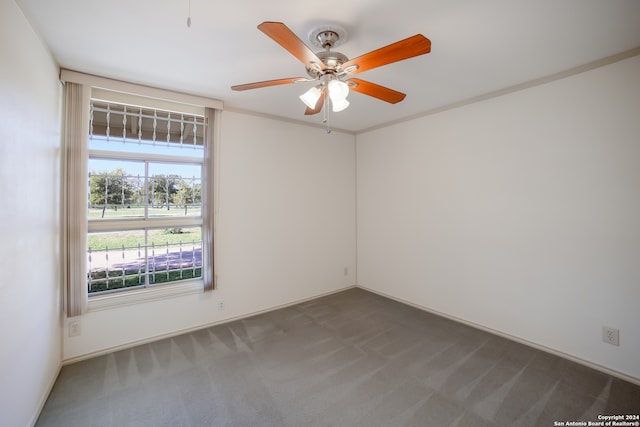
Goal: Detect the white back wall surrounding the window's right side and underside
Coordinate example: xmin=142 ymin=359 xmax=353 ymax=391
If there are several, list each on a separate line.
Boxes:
xmin=64 ymin=111 xmax=356 ymax=359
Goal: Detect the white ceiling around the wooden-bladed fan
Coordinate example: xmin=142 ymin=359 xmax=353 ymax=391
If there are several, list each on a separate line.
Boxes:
xmin=16 ymin=0 xmax=640 ymax=132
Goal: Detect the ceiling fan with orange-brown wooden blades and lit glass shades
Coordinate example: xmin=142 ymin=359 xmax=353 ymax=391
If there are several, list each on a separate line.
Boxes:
xmin=231 ymin=22 xmax=431 ymax=121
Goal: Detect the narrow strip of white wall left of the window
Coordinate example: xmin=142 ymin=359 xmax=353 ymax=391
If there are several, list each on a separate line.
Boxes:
xmin=0 ymin=0 xmax=61 ymax=426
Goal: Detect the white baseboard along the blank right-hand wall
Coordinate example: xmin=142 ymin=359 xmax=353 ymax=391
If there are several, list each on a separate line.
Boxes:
xmin=355 ymin=285 xmax=640 ymax=386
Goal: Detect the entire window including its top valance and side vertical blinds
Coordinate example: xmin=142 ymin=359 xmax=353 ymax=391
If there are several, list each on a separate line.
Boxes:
xmin=61 ymin=77 xmax=222 ymax=317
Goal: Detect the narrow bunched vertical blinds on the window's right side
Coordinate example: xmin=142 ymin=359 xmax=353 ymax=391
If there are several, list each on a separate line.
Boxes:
xmin=202 ymin=108 xmax=220 ymax=291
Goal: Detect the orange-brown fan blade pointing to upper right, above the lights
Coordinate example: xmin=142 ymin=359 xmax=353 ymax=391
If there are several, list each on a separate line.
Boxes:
xmin=342 ymin=34 xmax=431 ymax=74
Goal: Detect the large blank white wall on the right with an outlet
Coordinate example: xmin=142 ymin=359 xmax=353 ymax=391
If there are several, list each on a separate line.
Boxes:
xmin=357 ymin=57 xmax=640 ymax=379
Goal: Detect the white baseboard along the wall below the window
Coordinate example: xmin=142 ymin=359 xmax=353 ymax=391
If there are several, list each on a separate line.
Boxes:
xmin=62 ymin=285 xmax=356 ymax=366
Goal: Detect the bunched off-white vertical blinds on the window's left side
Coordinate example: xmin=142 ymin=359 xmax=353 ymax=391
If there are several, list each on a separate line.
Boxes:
xmin=63 ymin=82 xmax=91 ymax=317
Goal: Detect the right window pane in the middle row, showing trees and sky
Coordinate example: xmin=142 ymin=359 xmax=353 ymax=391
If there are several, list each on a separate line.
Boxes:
xmin=149 ymin=163 xmax=202 ymax=217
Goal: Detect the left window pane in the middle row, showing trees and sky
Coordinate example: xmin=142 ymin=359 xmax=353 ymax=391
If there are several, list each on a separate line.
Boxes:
xmin=88 ymin=159 xmax=146 ymax=220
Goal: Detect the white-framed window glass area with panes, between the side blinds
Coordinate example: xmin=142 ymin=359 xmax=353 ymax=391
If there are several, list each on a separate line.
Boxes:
xmin=86 ymin=98 xmax=207 ymax=297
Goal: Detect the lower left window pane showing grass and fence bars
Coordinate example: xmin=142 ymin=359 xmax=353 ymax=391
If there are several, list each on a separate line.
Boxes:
xmin=87 ymin=230 xmax=146 ymax=294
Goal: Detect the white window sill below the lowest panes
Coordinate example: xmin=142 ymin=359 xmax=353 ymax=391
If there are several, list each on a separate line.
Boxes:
xmin=87 ymin=280 xmax=204 ymax=311
